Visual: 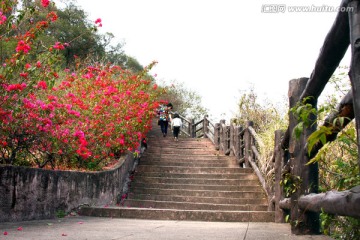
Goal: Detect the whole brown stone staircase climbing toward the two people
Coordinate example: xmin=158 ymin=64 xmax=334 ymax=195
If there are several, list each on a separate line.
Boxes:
xmin=80 ymin=123 xmax=274 ymax=222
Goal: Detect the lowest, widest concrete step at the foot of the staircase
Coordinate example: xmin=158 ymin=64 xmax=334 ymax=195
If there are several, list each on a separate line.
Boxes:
xmin=80 ymin=207 xmax=275 ymax=222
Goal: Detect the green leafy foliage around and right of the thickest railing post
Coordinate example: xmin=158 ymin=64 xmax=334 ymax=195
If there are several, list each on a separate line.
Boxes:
xmin=290 ymin=67 xmax=360 ymax=239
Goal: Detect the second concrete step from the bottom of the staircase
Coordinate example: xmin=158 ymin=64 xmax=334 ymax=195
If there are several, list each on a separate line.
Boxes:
xmin=122 ymin=199 xmax=267 ymax=211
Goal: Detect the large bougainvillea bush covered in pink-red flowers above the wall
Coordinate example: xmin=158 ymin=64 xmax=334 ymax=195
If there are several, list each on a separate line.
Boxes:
xmin=0 ymin=0 xmax=160 ymax=172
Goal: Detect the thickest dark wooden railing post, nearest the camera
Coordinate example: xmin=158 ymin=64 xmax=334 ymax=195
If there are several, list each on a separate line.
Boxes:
xmin=289 ymin=78 xmax=320 ymax=234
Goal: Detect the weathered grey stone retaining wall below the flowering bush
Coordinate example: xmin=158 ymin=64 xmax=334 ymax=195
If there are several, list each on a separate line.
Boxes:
xmin=0 ymin=153 xmax=135 ymax=222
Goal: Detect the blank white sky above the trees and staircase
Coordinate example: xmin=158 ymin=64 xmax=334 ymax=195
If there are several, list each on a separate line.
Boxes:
xmin=62 ymin=0 xmax=350 ymax=119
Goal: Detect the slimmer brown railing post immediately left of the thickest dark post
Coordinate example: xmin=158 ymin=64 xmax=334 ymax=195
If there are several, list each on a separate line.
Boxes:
xmin=274 ymin=130 xmax=285 ymax=223
